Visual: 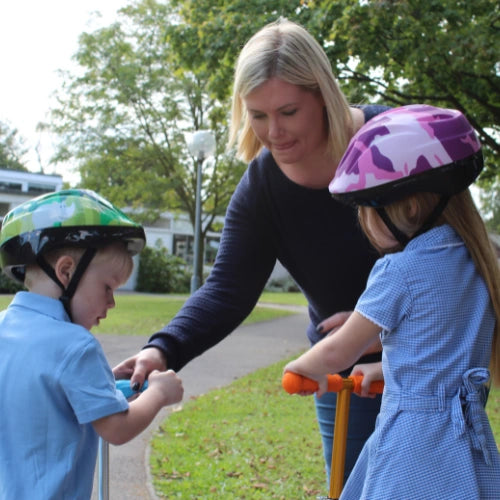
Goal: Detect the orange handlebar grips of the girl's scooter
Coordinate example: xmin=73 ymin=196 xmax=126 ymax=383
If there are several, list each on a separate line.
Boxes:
xmin=281 ymin=372 xmax=384 ymax=394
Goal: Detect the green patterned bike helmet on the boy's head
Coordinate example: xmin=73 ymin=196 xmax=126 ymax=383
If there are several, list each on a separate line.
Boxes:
xmin=0 ymin=189 xmax=146 ymax=281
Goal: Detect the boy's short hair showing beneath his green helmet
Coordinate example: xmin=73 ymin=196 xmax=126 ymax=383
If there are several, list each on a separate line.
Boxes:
xmin=24 ymin=241 xmax=134 ymax=290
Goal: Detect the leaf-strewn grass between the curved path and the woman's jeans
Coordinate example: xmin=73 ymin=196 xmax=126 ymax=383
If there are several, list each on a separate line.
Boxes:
xmin=150 ymin=361 xmax=326 ymax=500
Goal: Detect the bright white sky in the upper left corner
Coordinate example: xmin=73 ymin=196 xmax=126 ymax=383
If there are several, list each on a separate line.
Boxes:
xmin=0 ymin=0 xmax=131 ymax=183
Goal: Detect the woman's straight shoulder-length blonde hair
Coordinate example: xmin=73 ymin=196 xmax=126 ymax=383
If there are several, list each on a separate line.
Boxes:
xmin=228 ymin=18 xmax=353 ymax=164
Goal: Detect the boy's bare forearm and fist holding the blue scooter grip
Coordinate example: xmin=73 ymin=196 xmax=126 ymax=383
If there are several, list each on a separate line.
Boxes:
xmin=92 ymin=370 xmax=184 ymax=445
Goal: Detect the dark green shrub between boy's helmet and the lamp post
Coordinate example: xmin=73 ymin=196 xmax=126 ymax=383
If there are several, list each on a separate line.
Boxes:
xmin=136 ymin=246 xmax=190 ymax=293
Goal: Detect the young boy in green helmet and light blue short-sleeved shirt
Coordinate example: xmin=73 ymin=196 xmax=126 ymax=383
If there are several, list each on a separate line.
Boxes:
xmin=0 ymin=190 xmax=183 ymax=500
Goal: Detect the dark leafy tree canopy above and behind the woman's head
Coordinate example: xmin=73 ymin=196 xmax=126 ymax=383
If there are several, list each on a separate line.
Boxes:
xmin=170 ymin=0 xmax=500 ymax=229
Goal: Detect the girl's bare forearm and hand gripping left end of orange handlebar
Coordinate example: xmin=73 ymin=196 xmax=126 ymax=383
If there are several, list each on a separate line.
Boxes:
xmin=285 ymin=311 xmax=381 ymax=397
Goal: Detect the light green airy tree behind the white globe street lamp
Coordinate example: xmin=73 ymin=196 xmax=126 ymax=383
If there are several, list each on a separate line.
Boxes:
xmin=50 ymin=0 xmax=245 ymax=286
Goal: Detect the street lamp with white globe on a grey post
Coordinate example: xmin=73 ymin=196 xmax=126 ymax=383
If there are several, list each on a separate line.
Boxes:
xmin=187 ymin=130 xmax=215 ymax=293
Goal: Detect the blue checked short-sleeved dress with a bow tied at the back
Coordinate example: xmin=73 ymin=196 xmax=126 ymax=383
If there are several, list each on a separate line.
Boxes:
xmin=340 ymin=226 xmax=500 ymax=500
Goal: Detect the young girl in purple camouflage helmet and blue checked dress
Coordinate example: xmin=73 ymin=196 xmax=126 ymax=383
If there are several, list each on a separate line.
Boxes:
xmin=285 ymin=105 xmax=500 ymax=500
